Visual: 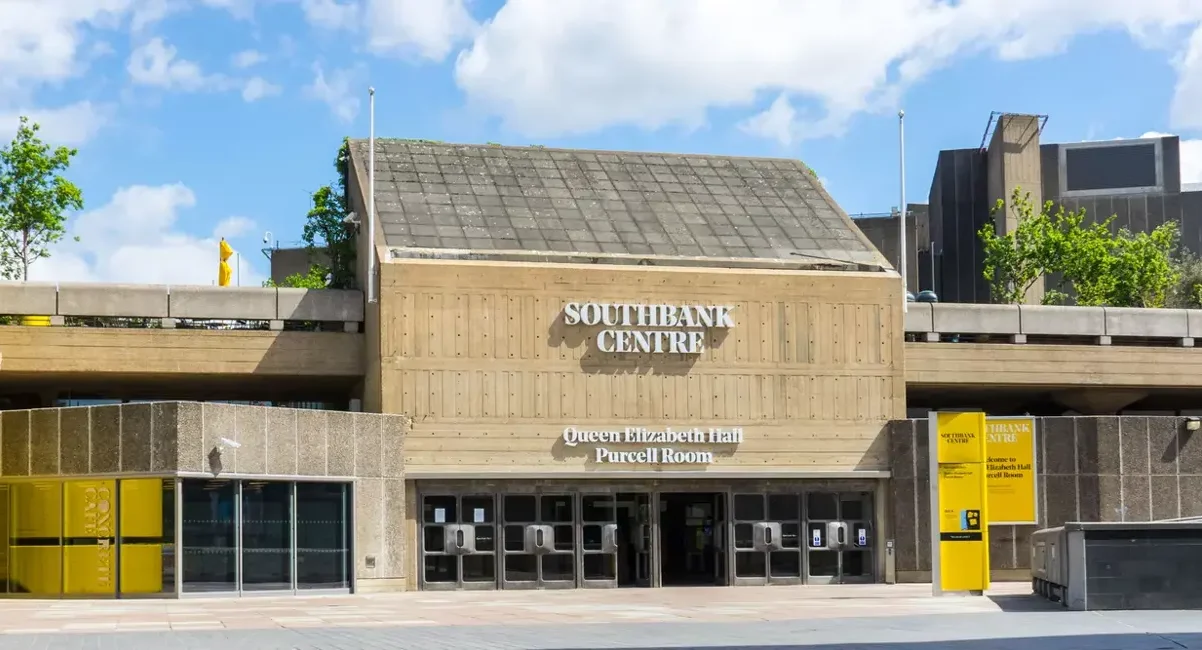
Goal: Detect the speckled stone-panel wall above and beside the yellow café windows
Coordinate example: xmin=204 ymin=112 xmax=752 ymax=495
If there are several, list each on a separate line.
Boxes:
xmin=0 ymin=402 xmax=407 ymax=589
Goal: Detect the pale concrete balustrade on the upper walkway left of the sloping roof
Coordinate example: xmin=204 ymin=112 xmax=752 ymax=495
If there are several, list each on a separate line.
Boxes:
xmin=0 ymin=282 xmax=363 ymax=332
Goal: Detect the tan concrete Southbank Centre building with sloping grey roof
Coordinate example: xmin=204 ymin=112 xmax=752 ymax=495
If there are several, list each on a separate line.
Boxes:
xmin=0 ymin=139 xmax=1202 ymax=597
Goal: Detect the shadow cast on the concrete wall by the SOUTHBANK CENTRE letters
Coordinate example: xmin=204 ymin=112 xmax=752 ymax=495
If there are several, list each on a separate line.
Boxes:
xmin=547 ymin=311 xmax=730 ymax=376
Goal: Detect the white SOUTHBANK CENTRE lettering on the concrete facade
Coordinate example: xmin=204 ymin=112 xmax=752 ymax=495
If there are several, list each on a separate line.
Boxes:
xmin=564 ymin=303 xmax=734 ymax=354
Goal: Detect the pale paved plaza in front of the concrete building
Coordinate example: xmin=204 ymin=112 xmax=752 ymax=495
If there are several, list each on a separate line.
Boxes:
xmin=0 ymin=585 xmax=1202 ymax=650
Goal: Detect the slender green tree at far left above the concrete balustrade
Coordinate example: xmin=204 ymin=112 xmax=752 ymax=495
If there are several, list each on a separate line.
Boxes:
xmin=0 ymin=117 xmax=83 ymax=280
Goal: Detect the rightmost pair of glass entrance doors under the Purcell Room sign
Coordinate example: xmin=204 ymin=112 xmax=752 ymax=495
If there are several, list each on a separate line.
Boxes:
xmin=805 ymin=491 xmax=875 ymax=584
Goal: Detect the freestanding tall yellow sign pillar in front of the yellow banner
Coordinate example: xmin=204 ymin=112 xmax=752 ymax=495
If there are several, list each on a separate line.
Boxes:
xmin=929 ymin=412 xmax=989 ymax=595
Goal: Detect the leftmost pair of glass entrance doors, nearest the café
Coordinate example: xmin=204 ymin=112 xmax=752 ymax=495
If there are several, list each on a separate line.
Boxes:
xmin=422 ymin=494 xmax=496 ymax=590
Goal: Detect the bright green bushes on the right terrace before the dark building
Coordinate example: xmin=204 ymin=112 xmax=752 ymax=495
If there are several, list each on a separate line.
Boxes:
xmin=977 ymin=189 xmax=1177 ymax=308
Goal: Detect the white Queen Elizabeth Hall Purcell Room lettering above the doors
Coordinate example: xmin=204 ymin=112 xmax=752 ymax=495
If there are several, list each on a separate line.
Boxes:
xmin=564 ymin=427 xmax=743 ymax=465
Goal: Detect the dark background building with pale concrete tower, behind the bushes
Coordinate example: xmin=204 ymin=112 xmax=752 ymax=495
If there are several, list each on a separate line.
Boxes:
xmin=918 ymin=113 xmax=1202 ymax=303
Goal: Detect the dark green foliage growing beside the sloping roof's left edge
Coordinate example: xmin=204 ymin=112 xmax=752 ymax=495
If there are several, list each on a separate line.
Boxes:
xmin=301 ymin=139 xmax=356 ymax=288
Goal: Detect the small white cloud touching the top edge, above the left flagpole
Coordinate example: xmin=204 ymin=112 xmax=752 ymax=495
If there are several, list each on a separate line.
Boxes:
xmin=363 ymin=0 xmax=475 ymax=61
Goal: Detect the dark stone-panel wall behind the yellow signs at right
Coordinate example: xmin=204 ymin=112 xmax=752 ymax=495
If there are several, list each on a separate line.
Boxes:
xmin=889 ymin=416 xmax=1202 ymax=582
